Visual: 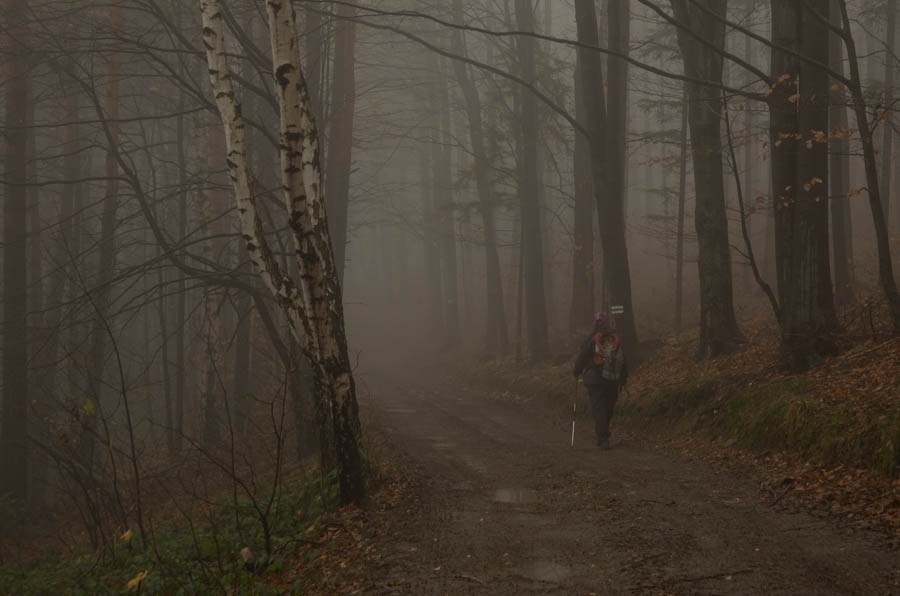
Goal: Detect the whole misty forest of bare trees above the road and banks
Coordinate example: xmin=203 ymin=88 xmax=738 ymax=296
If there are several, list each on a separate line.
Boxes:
xmin=0 ymin=0 xmax=900 ymax=546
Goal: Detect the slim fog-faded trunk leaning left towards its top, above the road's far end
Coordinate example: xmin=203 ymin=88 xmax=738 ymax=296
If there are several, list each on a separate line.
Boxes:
xmin=450 ymin=0 xmax=509 ymax=354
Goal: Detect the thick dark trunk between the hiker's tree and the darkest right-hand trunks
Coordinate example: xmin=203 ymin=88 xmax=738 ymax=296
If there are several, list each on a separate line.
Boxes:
xmin=672 ymin=0 xmax=741 ymax=357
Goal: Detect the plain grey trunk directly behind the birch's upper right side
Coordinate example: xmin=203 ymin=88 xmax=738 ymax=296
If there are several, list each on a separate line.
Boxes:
xmin=325 ymin=4 xmax=356 ymax=280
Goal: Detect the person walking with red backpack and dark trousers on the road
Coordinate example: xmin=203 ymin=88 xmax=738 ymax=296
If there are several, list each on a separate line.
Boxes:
xmin=572 ymin=312 xmax=628 ymax=450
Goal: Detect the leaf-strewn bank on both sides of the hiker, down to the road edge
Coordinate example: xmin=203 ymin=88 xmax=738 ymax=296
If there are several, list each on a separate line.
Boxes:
xmin=470 ymin=327 xmax=900 ymax=544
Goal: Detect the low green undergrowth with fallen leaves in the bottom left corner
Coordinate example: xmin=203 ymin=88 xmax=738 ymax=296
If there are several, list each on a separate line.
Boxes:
xmin=0 ymin=475 xmax=337 ymax=594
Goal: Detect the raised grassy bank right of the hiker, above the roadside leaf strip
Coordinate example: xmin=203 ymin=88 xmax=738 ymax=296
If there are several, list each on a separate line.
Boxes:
xmin=619 ymin=330 xmax=900 ymax=477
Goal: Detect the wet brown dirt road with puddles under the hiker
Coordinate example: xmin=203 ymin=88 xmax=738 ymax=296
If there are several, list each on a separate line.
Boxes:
xmin=337 ymin=383 xmax=900 ymax=594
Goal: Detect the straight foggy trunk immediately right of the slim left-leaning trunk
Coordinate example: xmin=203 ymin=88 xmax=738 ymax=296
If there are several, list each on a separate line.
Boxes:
xmin=515 ymin=0 xmax=549 ymax=360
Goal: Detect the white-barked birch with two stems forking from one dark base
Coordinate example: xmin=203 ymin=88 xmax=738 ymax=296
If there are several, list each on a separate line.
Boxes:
xmin=200 ymin=0 xmax=364 ymax=503
